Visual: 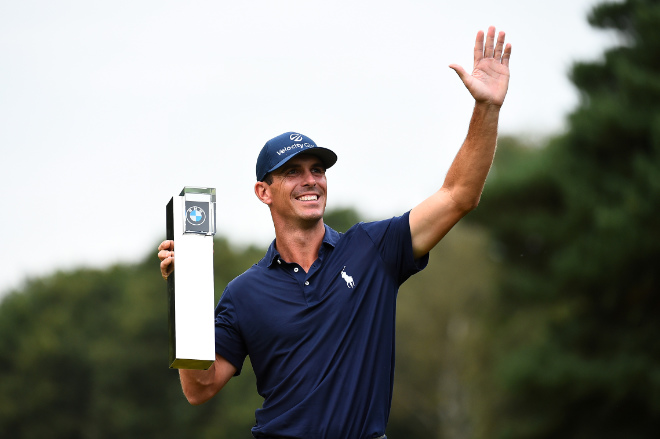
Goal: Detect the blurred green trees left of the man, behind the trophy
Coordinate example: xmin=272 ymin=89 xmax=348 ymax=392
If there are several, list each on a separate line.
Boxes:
xmin=0 ymin=239 xmax=263 ymax=439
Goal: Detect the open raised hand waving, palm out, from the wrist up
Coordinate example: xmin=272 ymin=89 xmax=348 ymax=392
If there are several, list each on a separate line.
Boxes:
xmin=449 ymin=26 xmax=511 ymax=106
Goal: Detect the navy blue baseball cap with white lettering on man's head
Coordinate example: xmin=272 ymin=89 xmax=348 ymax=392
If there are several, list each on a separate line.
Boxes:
xmin=257 ymin=131 xmax=337 ymax=181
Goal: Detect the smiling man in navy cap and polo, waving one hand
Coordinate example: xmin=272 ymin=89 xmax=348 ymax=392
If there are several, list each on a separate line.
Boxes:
xmin=158 ymin=27 xmax=511 ymax=439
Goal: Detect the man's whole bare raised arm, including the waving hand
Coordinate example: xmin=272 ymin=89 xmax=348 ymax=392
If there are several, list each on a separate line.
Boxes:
xmin=410 ymin=26 xmax=511 ymax=258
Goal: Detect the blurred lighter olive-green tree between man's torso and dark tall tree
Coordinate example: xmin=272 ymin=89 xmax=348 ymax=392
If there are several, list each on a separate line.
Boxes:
xmin=387 ymin=223 xmax=494 ymax=439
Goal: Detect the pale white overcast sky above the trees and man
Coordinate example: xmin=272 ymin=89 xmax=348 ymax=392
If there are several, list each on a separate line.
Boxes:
xmin=0 ymin=0 xmax=616 ymax=292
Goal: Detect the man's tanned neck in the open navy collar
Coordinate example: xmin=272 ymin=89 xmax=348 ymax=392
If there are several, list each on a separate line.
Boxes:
xmin=275 ymin=219 xmax=325 ymax=272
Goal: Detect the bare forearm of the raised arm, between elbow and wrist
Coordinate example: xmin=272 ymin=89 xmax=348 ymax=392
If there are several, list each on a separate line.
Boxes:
xmin=442 ymin=102 xmax=500 ymax=210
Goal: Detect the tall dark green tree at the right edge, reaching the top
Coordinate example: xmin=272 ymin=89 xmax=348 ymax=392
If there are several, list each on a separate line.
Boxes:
xmin=472 ymin=0 xmax=660 ymax=438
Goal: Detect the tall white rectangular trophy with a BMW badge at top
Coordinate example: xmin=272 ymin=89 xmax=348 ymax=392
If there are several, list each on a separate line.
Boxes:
xmin=166 ymin=186 xmax=215 ymax=369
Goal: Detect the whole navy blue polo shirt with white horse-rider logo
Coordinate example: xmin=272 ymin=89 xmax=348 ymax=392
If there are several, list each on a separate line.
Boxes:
xmin=215 ymin=213 xmax=428 ymax=439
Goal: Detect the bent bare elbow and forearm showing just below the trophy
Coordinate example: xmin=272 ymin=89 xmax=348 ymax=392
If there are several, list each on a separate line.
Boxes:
xmin=179 ymin=354 xmax=236 ymax=405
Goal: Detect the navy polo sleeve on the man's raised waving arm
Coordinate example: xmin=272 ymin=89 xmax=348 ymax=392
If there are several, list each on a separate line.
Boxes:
xmin=363 ymin=212 xmax=429 ymax=285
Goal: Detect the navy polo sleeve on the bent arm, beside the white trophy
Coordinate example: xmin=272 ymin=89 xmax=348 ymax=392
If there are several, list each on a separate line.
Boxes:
xmin=215 ymin=287 xmax=247 ymax=375
